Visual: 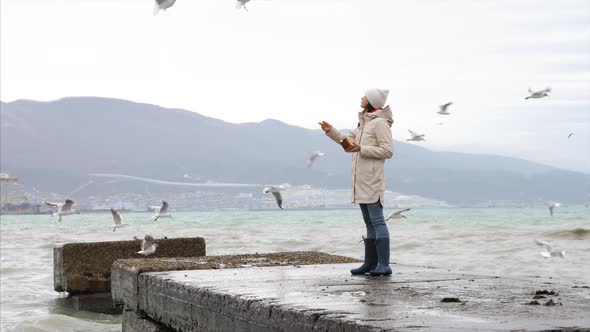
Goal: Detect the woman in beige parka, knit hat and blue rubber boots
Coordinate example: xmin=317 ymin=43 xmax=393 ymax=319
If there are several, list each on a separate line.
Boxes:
xmin=320 ymin=89 xmax=393 ymax=276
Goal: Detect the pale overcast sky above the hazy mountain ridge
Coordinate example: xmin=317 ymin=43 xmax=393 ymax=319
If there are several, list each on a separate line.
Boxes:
xmin=0 ymin=0 xmax=590 ymax=173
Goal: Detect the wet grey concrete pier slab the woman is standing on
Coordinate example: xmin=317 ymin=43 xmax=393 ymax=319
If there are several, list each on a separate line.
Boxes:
xmin=113 ymin=262 xmax=590 ymax=332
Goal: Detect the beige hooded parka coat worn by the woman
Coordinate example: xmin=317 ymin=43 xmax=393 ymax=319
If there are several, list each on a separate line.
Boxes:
xmin=327 ymin=106 xmax=393 ymax=204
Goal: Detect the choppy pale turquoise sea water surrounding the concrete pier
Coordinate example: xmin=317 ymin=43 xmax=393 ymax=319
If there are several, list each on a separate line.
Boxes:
xmin=0 ymin=207 xmax=590 ymax=331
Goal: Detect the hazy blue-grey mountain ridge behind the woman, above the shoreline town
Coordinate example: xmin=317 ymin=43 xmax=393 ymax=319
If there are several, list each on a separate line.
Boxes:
xmin=0 ymin=97 xmax=590 ymax=203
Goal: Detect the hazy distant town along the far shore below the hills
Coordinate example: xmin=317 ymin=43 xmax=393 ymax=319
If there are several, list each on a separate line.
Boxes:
xmin=0 ymin=173 xmax=580 ymax=214
